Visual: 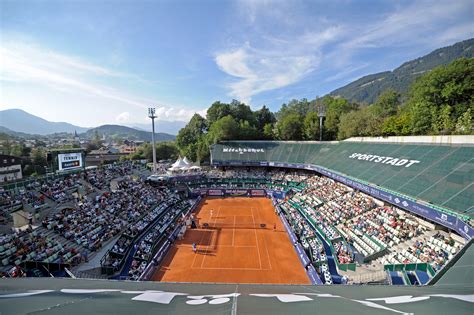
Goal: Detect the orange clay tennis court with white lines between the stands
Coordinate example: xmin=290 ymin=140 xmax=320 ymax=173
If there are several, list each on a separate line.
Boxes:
xmin=153 ymin=197 xmax=311 ymax=284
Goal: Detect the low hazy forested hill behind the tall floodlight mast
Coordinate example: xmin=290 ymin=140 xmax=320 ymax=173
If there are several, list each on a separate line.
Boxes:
xmin=80 ymin=125 xmax=175 ymax=141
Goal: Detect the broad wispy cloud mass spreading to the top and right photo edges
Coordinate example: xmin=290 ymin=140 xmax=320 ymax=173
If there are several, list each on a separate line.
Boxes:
xmin=215 ymin=0 xmax=474 ymax=103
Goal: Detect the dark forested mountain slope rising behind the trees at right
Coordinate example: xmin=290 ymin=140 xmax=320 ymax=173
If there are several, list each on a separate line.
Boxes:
xmin=329 ymin=38 xmax=474 ymax=104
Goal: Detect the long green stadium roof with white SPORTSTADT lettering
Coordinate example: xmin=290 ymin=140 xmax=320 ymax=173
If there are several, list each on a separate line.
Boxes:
xmin=211 ymin=141 xmax=474 ymax=218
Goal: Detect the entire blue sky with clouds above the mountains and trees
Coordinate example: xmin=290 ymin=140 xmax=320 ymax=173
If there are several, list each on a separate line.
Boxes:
xmin=0 ymin=0 xmax=474 ymax=131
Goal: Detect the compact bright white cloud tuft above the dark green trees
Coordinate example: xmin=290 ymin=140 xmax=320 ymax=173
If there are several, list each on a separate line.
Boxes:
xmin=215 ymin=27 xmax=340 ymax=103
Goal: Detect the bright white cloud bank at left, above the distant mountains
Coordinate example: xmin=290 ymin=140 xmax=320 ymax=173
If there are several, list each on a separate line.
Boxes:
xmin=0 ymin=41 xmax=207 ymax=123
